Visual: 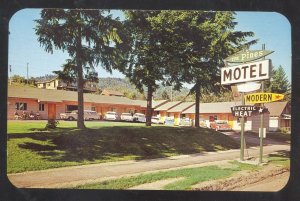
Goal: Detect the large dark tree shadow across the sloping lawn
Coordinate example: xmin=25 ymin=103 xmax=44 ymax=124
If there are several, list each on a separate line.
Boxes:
xmin=8 ymin=126 xmax=239 ymax=162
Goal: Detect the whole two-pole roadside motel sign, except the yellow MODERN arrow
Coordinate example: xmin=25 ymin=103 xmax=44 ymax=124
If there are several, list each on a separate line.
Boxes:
xmin=221 ymin=44 xmax=273 ymax=163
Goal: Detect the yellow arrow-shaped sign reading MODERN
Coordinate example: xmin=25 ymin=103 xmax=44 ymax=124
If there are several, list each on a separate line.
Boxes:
xmin=245 ymin=93 xmax=284 ymax=104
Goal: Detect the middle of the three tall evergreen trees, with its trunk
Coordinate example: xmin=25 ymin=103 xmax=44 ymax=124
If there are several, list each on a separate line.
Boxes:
xmin=120 ymin=11 xmax=164 ymax=126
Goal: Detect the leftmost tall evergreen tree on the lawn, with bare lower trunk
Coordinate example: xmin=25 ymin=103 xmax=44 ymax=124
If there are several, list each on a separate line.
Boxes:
xmin=35 ymin=9 xmax=125 ymax=129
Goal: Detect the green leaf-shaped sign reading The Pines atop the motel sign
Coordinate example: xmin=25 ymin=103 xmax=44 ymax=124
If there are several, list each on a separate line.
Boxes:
xmin=225 ymin=50 xmax=274 ymax=63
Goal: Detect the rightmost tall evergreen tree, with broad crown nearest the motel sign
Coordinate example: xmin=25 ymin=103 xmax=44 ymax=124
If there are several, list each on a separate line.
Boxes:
xmin=150 ymin=11 xmax=256 ymax=127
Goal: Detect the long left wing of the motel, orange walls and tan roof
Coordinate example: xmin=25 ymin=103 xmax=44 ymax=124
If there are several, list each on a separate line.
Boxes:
xmin=7 ymin=85 xmax=141 ymax=119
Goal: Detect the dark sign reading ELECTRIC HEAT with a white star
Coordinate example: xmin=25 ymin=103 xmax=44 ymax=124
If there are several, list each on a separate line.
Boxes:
xmin=231 ymin=105 xmax=268 ymax=117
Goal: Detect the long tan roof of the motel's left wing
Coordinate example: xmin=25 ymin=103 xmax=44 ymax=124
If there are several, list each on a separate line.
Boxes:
xmin=8 ymin=85 xmax=139 ymax=106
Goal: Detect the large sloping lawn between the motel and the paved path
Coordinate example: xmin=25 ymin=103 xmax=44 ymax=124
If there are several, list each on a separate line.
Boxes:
xmin=7 ymin=121 xmax=239 ymax=173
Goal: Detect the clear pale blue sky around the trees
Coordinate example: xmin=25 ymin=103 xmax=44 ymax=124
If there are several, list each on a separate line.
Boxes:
xmin=8 ymin=9 xmax=292 ymax=88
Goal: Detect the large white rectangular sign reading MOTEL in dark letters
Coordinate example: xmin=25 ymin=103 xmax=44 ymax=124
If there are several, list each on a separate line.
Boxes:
xmin=221 ymin=59 xmax=271 ymax=85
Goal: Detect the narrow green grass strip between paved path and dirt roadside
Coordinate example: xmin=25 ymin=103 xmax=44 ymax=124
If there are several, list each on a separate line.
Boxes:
xmin=77 ymin=161 xmax=260 ymax=190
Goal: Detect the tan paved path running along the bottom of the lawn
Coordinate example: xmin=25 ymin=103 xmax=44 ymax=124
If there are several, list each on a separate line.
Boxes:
xmin=8 ymin=145 xmax=290 ymax=188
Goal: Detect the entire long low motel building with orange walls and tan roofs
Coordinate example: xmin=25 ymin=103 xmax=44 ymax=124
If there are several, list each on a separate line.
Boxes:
xmin=7 ymin=85 xmax=291 ymax=132
